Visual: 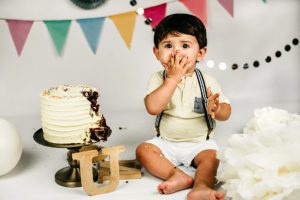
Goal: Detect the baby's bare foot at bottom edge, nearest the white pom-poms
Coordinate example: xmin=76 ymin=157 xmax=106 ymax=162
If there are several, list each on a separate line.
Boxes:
xmin=187 ymin=186 xmax=224 ymax=200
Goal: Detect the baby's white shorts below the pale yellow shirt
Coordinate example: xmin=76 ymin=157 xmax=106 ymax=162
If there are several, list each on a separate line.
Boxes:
xmin=146 ymin=137 xmax=219 ymax=167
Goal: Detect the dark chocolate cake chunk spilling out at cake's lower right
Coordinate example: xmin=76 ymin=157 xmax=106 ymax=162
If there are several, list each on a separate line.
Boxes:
xmin=90 ymin=115 xmax=111 ymax=141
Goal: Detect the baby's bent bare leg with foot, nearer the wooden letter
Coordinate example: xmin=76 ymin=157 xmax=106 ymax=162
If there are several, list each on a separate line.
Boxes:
xmin=136 ymin=143 xmax=193 ymax=194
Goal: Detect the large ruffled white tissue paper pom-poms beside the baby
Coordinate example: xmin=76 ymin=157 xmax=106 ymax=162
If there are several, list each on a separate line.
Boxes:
xmin=217 ymin=107 xmax=300 ymax=200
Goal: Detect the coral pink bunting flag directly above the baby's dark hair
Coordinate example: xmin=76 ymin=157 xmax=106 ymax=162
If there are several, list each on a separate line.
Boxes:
xmin=179 ymin=0 xmax=207 ymax=26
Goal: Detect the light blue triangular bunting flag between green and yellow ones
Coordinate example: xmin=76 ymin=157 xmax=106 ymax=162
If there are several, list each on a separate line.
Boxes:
xmin=77 ymin=17 xmax=105 ymax=54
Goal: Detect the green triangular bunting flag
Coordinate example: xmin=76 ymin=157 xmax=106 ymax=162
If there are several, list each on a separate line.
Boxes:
xmin=44 ymin=20 xmax=71 ymax=55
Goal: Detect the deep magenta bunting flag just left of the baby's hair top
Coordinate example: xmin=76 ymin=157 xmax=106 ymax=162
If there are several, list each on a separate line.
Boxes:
xmin=144 ymin=3 xmax=167 ymax=28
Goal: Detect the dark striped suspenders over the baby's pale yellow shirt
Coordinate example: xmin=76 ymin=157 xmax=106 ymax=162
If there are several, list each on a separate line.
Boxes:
xmin=155 ymin=68 xmax=213 ymax=140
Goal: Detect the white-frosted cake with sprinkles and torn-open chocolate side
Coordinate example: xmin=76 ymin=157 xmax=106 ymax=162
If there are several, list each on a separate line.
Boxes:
xmin=40 ymin=84 xmax=110 ymax=144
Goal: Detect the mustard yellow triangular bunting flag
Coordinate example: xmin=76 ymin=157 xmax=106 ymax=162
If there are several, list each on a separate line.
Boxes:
xmin=109 ymin=11 xmax=136 ymax=49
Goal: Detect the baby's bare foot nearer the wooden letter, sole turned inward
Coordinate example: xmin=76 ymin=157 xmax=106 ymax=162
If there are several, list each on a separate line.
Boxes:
xmin=157 ymin=169 xmax=194 ymax=194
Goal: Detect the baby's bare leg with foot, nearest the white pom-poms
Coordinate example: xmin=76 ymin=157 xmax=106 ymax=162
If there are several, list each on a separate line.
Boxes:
xmin=187 ymin=150 xmax=224 ymax=200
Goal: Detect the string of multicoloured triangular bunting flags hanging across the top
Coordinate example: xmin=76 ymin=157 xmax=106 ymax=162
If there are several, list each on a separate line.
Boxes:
xmin=0 ymin=0 xmax=274 ymax=68
